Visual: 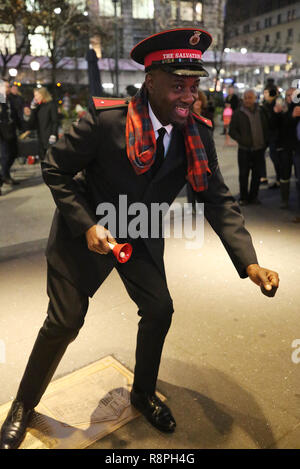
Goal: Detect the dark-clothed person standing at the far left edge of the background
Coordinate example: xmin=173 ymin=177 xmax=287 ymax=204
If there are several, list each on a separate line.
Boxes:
xmin=0 ymin=80 xmax=22 ymax=195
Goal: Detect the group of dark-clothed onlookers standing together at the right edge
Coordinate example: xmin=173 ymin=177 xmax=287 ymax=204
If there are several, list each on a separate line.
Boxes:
xmin=224 ymin=83 xmax=300 ymax=223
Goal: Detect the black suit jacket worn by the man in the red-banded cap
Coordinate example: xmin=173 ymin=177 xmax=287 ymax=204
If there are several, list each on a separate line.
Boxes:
xmin=42 ymin=108 xmax=257 ymax=296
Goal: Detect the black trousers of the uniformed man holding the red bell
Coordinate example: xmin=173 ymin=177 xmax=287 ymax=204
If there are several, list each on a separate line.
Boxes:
xmin=16 ymin=248 xmax=173 ymax=408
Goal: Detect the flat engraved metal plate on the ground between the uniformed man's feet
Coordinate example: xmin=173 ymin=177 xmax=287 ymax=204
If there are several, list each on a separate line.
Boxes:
xmin=0 ymin=356 xmax=164 ymax=449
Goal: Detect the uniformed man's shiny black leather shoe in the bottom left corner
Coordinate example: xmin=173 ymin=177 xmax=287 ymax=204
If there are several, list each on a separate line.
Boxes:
xmin=0 ymin=400 xmax=33 ymax=449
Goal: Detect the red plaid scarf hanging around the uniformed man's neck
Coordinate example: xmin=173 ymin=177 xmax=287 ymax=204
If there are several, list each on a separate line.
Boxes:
xmin=126 ymin=84 xmax=211 ymax=192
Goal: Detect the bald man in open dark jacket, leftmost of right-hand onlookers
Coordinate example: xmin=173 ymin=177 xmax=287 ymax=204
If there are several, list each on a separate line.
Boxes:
xmin=229 ymin=90 xmax=268 ymax=205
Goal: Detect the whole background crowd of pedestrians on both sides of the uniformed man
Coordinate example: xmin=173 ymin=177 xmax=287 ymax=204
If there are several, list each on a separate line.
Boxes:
xmin=0 ymin=80 xmax=300 ymax=223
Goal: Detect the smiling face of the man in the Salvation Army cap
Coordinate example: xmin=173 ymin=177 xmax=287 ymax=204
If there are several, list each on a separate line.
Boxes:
xmin=145 ymin=70 xmax=200 ymax=127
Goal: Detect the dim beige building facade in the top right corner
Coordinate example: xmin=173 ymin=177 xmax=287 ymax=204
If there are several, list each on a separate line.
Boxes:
xmin=225 ymin=0 xmax=300 ymax=88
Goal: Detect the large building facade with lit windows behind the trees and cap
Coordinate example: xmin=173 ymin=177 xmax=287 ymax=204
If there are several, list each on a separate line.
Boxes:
xmin=0 ymin=0 xmax=225 ymax=94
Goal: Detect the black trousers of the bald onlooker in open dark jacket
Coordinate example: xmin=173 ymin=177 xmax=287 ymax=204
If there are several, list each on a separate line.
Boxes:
xmin=238 ymin=148 xmax=264 ymax=201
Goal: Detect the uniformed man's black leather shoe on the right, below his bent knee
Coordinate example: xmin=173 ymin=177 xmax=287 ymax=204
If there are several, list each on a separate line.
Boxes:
xmin=130 ymin=389 xmax=176 ymax=433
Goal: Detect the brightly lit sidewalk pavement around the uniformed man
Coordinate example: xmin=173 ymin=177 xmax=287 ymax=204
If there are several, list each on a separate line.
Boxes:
xmin=0 ymin=128 xmax=300 ymax=449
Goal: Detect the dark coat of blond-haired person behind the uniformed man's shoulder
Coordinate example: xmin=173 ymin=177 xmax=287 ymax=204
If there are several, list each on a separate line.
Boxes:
xmin=26 ymin=101 xmax=58 ymax=159
